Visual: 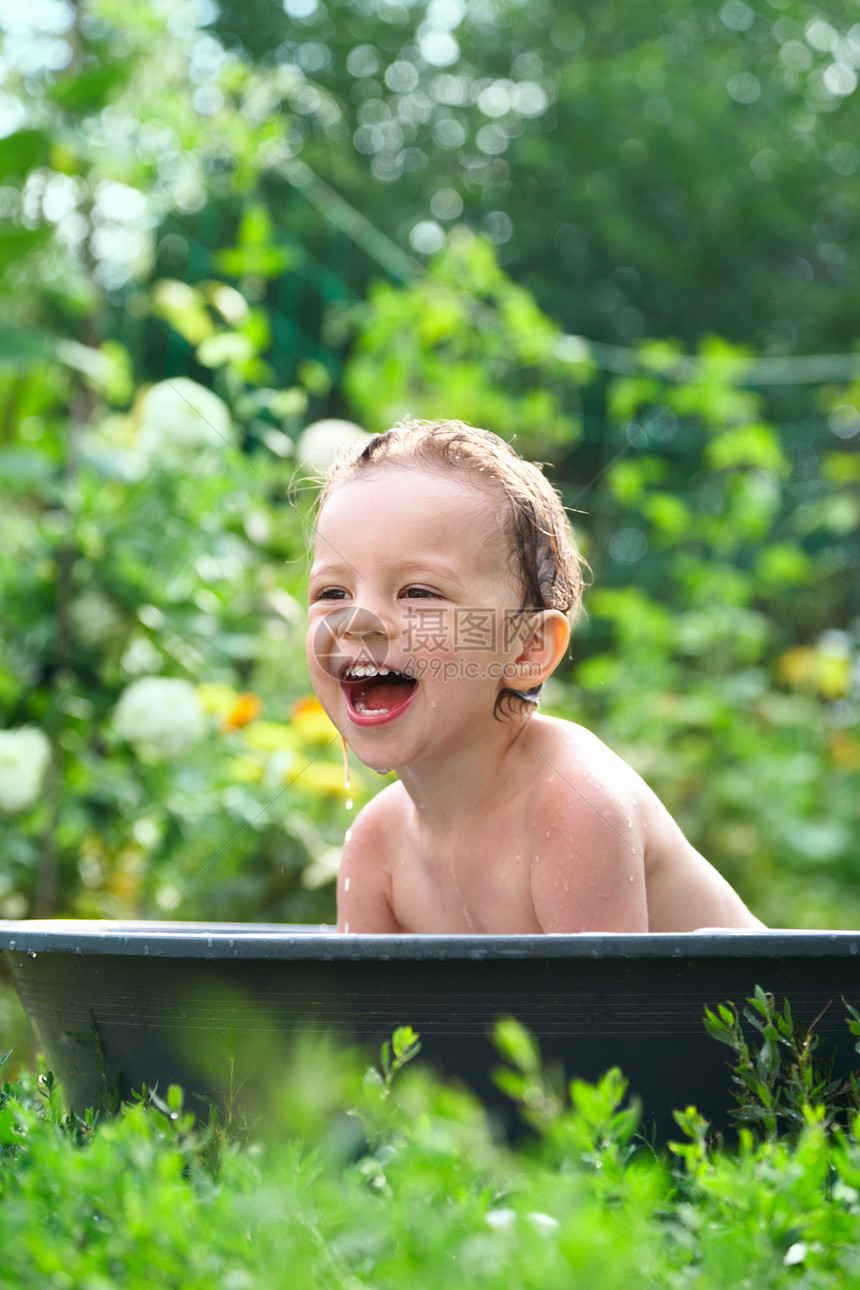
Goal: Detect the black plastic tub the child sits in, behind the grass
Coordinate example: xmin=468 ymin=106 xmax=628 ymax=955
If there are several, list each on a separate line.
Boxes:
xmin=0 ymin=921 xmax=860 ymax=1138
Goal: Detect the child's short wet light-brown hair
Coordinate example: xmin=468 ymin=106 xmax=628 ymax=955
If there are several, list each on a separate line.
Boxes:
xmin=320 ymin=421 xmax=585 ymax=711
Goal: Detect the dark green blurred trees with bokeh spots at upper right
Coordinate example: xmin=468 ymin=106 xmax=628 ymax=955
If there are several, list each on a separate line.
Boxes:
xmin=202 ymin=0 xmax=859 ymax=353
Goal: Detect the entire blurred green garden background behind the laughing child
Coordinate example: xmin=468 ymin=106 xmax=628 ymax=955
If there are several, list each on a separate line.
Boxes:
xmin=0 ymin=0 xmax=860 ymax=926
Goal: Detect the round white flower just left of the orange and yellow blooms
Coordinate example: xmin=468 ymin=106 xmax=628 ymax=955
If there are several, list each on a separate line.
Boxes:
xmin=113 ymin=676 xmax=206 ymax=757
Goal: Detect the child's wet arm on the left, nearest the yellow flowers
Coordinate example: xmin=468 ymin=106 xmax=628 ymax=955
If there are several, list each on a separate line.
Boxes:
xmin=338 ymin=791 xmax=401 ymax=931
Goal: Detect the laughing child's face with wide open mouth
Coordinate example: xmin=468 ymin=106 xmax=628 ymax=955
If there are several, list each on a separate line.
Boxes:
xmin=307 ymin=463 xmax=529 ymax=770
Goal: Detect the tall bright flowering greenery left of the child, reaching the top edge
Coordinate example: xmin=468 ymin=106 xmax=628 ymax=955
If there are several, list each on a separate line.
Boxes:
xmin=0 ymin=0 xmax=379 ymax=921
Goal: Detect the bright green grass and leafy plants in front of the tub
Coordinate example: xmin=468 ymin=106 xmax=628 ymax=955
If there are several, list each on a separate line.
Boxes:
xmin=0 ymin=1011 xmax=860 ymax=1290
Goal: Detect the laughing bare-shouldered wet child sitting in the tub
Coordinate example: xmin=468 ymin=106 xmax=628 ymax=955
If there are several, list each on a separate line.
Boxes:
xmin=308 ymin=422 xmax=762 ymax=934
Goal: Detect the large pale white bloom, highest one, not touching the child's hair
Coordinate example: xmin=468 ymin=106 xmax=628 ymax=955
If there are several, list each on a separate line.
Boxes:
xmin=138 ymin=377 xmax=233 ymax=464
